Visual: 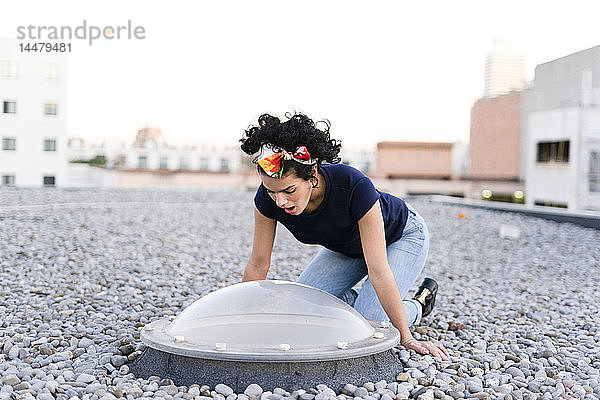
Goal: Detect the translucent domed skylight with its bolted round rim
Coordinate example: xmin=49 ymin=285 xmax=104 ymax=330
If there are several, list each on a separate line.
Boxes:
xmin=141 ymin=280 xmax=399 ymax=361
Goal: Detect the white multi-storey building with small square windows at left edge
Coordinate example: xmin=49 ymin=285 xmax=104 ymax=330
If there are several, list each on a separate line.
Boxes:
xmin=0 ymin=38 xmax=67 ymax=186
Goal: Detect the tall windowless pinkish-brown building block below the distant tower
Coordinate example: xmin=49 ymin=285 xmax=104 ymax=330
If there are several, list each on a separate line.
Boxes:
xmin=469 ymin=92 xmax=521 ymax=180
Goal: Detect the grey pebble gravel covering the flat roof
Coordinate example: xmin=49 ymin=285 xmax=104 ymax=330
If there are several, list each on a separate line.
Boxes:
xmin=0 ymin=188 xmax=600 ymax=400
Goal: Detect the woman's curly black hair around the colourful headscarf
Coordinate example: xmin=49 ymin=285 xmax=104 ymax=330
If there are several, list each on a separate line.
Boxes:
xmin=240 ymin=113 xmax=342 ymax=180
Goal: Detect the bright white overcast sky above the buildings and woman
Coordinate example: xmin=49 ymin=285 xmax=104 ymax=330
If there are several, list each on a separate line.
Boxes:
xmin=0 ymin=0 xmax=600 ymax=149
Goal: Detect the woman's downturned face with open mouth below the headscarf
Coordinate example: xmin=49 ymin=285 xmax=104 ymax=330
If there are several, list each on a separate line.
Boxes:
xmin=260 ymin=171 xmax=312 ymax=215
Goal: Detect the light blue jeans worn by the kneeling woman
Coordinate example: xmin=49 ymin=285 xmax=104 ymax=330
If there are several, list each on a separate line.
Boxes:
xmin=298 ymin=203 xmax=429 ymax=326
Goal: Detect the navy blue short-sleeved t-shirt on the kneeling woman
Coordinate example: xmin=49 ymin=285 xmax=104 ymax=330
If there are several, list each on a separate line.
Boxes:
xmin=254 ymin=164 xmax=408 ymax=258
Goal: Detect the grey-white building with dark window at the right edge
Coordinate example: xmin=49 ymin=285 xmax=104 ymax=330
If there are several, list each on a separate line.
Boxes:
xmin=522 ymin=46 xmax=600 ymax=210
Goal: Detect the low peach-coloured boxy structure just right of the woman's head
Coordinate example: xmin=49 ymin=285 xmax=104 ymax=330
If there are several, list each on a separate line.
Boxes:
xmin=373 ymin=142 xmax=452 ymax=179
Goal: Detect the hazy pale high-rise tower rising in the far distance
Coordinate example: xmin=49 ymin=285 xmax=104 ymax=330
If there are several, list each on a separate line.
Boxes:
xmin=483 ymin=39 xmax=525 ymax=98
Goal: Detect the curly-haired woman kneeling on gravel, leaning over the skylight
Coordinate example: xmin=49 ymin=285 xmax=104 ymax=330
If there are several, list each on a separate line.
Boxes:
xmin=240 ymin=114 xmax=449 ymax=360
